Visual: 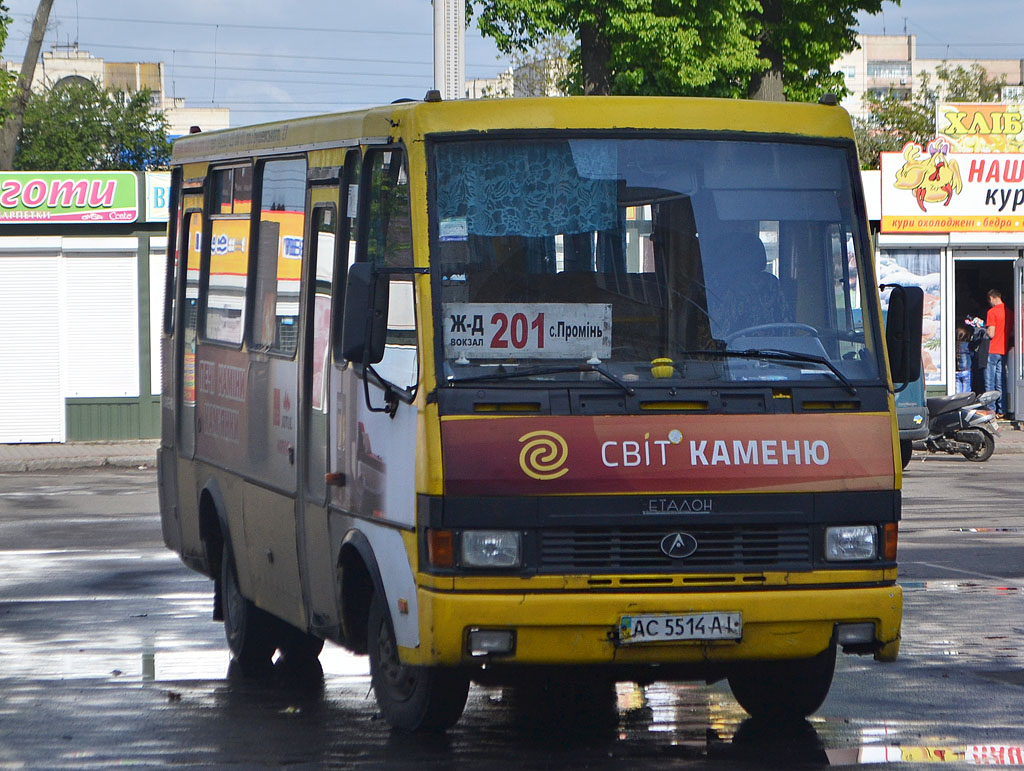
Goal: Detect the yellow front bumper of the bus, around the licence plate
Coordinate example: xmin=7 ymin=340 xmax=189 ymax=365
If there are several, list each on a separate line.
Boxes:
xmin=400 ymin=585 xmax=903 ymax=667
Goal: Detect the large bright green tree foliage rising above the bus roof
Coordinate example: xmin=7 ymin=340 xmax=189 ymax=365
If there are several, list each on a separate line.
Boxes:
xmin=470 ymin=0 xmax=898 ymax=100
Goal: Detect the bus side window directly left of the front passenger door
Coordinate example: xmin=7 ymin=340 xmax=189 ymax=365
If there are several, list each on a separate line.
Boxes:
xmin=253 ymin=158 xmax=306 ymax=356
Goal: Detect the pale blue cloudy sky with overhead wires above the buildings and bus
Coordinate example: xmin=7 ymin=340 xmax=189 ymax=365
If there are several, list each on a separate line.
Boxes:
xmin=0 ymin=0 xmax=1024 ymax=126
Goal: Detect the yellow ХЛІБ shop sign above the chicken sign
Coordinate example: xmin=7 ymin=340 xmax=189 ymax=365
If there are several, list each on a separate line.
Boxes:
xmin=935 ymin=101 xmax=1024 ymax=153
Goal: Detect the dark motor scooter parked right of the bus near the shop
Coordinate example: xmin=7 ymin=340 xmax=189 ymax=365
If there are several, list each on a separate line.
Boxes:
xmin=913 ymin=391 xmax=999 ymax=463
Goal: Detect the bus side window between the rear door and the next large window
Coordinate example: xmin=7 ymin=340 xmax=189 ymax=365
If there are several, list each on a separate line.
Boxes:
xmin=203 ymin=166 xmax=252 ymax=345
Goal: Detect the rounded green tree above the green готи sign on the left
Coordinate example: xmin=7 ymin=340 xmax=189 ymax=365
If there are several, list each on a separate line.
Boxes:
xmin=14 ymin=81 xmax=170 ymax=171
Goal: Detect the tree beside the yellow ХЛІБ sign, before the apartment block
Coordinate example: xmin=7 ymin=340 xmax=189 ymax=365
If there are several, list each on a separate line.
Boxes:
xmin=853 ymin=61 xmax=1007 ymax=169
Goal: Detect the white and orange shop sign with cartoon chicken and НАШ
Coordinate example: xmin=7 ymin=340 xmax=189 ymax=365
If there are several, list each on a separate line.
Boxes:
xmin=881 ymin=137 xmax=1024 ymax=233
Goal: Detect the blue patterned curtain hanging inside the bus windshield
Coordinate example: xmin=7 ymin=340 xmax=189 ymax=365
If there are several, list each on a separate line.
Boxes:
xmin=434 ymin=141 xmax=618 ymax=237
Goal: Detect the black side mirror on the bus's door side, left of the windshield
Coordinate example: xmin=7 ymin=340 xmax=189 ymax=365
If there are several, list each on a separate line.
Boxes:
xmin=341 ymin=262 xmax=390 ymax=365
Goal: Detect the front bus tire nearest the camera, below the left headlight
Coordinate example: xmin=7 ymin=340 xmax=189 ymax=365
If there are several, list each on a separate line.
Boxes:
xmin=367 ymin=592 xmax=469 ymax=731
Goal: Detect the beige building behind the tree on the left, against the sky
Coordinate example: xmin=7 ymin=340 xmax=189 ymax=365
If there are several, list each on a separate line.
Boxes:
xmin=3 ymin=44 xmax=230 ymax=136
